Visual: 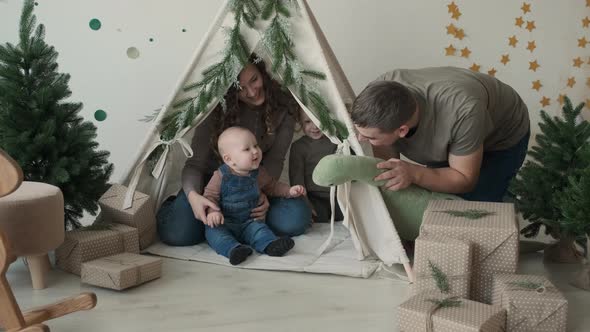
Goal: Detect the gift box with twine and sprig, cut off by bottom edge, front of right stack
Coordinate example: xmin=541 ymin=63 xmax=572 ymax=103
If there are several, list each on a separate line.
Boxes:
xmin=398 ymin=291 xmax=506 ymax=332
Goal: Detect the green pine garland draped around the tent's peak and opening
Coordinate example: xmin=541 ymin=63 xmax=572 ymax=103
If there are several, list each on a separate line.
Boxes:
xmin=155 ymin=0 xmax=348 ymax=145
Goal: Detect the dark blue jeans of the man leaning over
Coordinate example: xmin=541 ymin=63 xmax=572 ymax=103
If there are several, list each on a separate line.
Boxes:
xmin=430 ymin=131 xmax=531 ymax=202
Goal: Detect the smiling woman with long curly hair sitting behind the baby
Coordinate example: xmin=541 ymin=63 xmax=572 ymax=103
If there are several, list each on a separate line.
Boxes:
xmin=158 ymin=55 xmax=311 ymax=246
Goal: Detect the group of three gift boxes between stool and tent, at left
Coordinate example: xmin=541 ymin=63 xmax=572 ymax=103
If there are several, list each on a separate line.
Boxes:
xmin=55 ymin=184 xmax=162 ymax=290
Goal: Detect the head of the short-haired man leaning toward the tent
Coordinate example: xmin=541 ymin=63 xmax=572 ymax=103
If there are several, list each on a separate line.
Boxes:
xmin=350 ymin=81 xmax=418 ymax=145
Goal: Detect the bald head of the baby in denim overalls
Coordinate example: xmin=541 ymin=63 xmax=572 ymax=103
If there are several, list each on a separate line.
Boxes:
xmin=217 ymin=127 xmax=262 ymax=173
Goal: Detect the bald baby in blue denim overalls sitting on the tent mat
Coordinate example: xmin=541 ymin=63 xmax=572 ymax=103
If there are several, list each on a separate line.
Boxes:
xmin=203 ymin=127 xmax=305 ymax=265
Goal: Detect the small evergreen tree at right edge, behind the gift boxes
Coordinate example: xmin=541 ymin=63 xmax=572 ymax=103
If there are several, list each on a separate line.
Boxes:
xmin=511 ymin=97 xmax=590 ymax=262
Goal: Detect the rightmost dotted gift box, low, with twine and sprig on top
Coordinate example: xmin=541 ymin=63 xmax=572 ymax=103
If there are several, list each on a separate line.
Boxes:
xmin=492 ymin=274 xmax=567 ymax=332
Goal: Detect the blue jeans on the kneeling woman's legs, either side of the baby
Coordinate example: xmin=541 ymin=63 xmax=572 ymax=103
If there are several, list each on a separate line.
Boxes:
xmin=157 ymin=189 xmax=311 ymax=246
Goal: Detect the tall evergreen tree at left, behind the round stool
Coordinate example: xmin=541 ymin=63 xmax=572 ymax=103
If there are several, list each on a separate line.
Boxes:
xmin=0 ymin=0 xmax=113 ymax=228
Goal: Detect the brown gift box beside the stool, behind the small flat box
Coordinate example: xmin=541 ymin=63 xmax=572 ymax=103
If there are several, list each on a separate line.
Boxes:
xmin=55 ymin=224 xmax=139 ymax=275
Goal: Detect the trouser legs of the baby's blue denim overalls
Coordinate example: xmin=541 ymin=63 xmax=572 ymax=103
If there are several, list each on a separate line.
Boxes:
xmin=205 ymin=219 xmax=277 ymax=258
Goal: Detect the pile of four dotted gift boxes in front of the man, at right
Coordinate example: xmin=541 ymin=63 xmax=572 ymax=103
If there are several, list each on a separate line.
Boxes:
xmin=398 ymin=200 xmax=567 ymax=332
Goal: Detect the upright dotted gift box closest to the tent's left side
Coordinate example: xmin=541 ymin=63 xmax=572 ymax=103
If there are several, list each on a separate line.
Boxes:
xmin=98 ymin=184 xmax=157 ymax=250
